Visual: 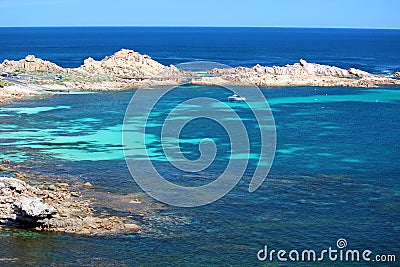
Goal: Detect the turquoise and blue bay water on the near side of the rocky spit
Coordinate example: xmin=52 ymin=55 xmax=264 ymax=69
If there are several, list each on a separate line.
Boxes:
xmin=0 ymin=86 xmax=400 ymax=266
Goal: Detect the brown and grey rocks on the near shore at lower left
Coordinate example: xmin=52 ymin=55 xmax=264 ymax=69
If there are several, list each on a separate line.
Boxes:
xmin=0 ymin=160 xmax=141 ymax=235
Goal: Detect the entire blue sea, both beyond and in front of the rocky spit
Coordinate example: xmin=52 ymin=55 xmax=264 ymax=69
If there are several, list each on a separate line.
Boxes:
xmin=0 ymin=27 xmax=400 ymax=266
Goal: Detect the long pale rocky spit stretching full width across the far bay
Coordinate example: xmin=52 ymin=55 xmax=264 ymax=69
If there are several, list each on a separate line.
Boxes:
xmin=0 ymin=49 xmax=400 ymax=102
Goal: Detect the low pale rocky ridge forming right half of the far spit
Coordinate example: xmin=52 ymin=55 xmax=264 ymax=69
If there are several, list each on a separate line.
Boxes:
xmin=208 ymin=59 xmax=399 ymax=87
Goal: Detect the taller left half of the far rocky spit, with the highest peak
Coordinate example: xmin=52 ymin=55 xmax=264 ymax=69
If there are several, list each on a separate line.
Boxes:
xmin=0 ymin=49 xmax=184 ymax=93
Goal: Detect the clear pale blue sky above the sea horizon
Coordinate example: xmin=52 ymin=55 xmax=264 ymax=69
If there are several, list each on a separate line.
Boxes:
xmin=0 ymin=0 xmax=400 ymax=29
